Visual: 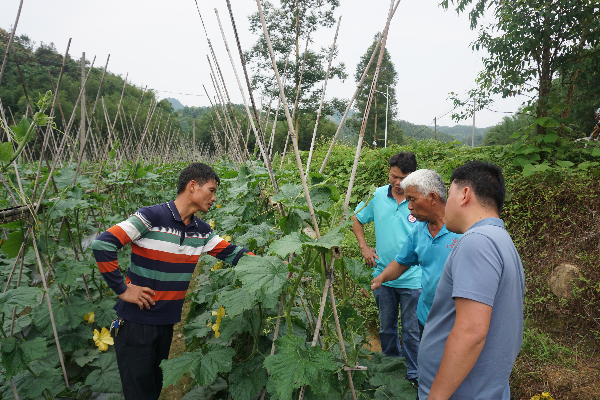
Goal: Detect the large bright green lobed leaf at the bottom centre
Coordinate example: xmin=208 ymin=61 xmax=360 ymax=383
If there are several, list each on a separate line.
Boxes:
xmin=264 ymin=335 xmax=337 ymax=400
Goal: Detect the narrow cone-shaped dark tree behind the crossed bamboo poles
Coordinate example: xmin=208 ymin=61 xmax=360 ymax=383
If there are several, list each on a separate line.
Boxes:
xmin=348 ymin=33 xmax=404 ymax=146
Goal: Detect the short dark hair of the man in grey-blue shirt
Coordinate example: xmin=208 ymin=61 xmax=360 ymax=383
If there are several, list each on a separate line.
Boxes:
xmin=450 ymin=161 xmax=506 ymax=213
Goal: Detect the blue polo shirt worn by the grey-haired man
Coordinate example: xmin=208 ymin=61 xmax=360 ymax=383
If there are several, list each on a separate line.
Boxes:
xmin=395 ymin=222 xmax=462 ymax=325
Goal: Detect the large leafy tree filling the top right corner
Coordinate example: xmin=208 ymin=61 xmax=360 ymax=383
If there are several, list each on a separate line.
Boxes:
xmin=442 ymin=0 xmax=600 ymax=135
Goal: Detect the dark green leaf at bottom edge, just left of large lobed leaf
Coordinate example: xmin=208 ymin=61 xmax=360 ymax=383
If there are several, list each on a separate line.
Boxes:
xmin=229 ymin=357 xmax=268 ymax=400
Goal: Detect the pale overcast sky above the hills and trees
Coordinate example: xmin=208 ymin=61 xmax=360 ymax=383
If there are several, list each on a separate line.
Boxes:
xmin=0 ymin=0 xmax=523 ymax=127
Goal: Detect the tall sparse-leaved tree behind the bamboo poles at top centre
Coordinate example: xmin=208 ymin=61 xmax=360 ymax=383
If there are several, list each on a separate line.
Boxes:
xmin=245 ymin=0 xmax=347 ymax=150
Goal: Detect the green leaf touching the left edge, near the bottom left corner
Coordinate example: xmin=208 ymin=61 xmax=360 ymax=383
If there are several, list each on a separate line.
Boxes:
xmin=0 ymin=337 xmax=46 ymax=378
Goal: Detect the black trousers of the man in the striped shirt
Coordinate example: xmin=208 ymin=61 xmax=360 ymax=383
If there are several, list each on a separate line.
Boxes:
xmin=115 ymin=321 xmax=173 ymax=400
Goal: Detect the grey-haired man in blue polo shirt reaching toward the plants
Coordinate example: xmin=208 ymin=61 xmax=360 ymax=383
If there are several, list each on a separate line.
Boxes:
xmin=371 ymin=169 xmax=461 ymax=335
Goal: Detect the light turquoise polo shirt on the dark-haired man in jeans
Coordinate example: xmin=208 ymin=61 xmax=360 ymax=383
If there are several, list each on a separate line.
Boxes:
xmin=355 ymin=185 xmax=421 ymax=289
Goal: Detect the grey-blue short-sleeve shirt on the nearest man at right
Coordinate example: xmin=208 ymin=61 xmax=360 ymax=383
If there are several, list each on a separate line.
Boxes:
xmin=418 ymin=218 xmax=525 ymax=400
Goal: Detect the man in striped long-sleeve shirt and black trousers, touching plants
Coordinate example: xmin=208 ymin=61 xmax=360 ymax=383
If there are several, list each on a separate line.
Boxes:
xmin=92 ymin=163 xmax=252 ymax=400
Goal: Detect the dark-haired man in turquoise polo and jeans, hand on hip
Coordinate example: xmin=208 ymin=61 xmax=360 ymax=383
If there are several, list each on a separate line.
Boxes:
xmin=352 ymin=152 xmax=421 ymax=381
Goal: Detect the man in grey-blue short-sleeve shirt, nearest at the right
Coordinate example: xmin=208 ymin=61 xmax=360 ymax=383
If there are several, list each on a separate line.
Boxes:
xmin=419 ymin=161 xmax=525 ymax=400
